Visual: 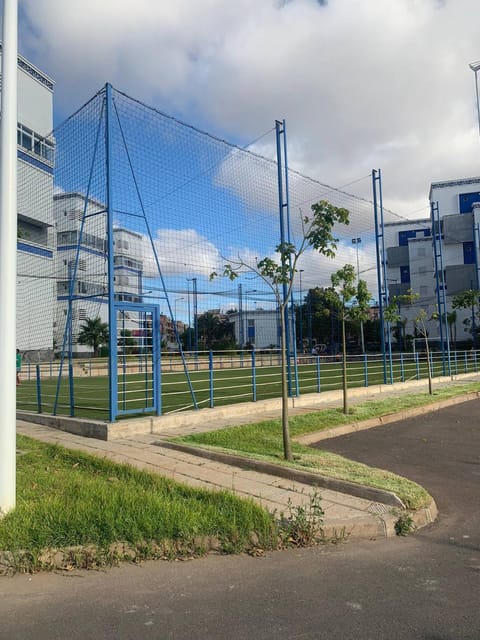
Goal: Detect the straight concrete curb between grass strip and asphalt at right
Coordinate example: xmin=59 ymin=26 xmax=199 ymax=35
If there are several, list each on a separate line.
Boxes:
xmin=293 ymin=391 xmax=480 ymax=445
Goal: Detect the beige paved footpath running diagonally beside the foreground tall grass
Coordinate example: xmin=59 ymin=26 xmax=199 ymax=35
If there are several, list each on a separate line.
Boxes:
xmin=17 ymin=420 xmax=404 ymax=538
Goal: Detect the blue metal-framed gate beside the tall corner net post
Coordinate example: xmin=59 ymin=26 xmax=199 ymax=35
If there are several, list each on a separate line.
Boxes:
xmin=110 ymin=302 xmax=161 ymax=419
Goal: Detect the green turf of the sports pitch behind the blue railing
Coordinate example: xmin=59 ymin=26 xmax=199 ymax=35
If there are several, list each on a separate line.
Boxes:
xmin=17 ymin=358 xmax=472 ymax=420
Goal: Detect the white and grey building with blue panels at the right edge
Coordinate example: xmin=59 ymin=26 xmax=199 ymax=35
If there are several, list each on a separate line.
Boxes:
xmin=384 ymin=178 xmax=480 ymax=339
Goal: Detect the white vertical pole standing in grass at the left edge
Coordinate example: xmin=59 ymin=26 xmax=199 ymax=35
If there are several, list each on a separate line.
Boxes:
xmin=0 ymin=0 xmax=18 ymax=514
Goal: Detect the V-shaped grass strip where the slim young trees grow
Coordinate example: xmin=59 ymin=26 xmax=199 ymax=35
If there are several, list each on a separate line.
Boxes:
xmin=175 ymin=383 xmax=480 ymax=509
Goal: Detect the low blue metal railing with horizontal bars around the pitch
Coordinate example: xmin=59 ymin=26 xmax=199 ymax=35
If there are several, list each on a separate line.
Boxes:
xmin=17 ymin=350 xmax=479 ymax=419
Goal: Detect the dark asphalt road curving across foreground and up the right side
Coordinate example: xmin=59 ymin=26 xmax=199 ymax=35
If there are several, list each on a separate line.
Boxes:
xmin=0 ymin=400 xmax=480 ymax=640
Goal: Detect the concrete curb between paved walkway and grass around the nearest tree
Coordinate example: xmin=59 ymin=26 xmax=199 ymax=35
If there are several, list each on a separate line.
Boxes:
xmin=158 ymin=440 xmax=405 ymax=509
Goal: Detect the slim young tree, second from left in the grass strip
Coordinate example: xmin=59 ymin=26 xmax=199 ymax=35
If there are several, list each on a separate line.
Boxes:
xmin=328 ymin=264 xmax=371 ymax=414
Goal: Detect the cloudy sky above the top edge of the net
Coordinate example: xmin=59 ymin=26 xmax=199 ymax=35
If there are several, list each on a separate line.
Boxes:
xmin=7 ymin=0 xmax=480 ymax=310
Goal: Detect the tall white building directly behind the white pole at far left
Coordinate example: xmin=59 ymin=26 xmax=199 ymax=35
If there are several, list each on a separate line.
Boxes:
xmin=0 ymin=45 xmax=55 ymax=361
